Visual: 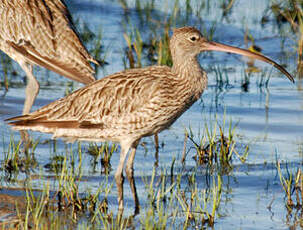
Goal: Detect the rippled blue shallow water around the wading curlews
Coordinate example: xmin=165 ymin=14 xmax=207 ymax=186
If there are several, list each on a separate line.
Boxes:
xmin=0 ymin=0 xmax=303 ymax=229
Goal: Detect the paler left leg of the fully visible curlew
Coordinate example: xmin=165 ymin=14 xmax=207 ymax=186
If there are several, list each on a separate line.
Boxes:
xmin=115 ymin=143 xmax=130 ymax=213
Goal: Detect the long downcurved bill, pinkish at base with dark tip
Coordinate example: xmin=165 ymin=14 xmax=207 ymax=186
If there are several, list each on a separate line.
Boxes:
xmin=202 ymin=40 xmax=295 ymax=83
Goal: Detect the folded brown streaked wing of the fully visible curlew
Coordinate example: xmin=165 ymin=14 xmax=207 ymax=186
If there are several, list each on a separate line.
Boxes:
xmin=6 ymin=66 xmax=168 ymax=120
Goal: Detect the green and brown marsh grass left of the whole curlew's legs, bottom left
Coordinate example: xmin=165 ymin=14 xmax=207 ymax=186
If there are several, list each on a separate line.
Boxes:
xmin=0 ymin=145 xmax=112 ymax=229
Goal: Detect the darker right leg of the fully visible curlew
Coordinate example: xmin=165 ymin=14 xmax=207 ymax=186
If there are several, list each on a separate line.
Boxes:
xmin=125 ymin=141 xmax=140 ymax=215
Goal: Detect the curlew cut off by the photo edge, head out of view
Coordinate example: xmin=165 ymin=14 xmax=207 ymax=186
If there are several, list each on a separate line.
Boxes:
xmin=0 ymin=0 xmax=98 ymax=114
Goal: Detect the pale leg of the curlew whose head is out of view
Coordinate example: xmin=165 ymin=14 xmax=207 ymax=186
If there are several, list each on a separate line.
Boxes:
xmin=20 ymin=63 xmax=40 ymax=114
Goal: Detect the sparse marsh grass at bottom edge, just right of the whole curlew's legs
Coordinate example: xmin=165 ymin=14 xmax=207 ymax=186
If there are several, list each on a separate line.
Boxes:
xmin=140 ymin=164 xmax=223 ymax=229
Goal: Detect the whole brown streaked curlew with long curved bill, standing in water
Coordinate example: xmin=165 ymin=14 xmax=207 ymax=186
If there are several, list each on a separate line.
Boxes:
xmin=8 ymin=27 xmax=294 ymax=213
